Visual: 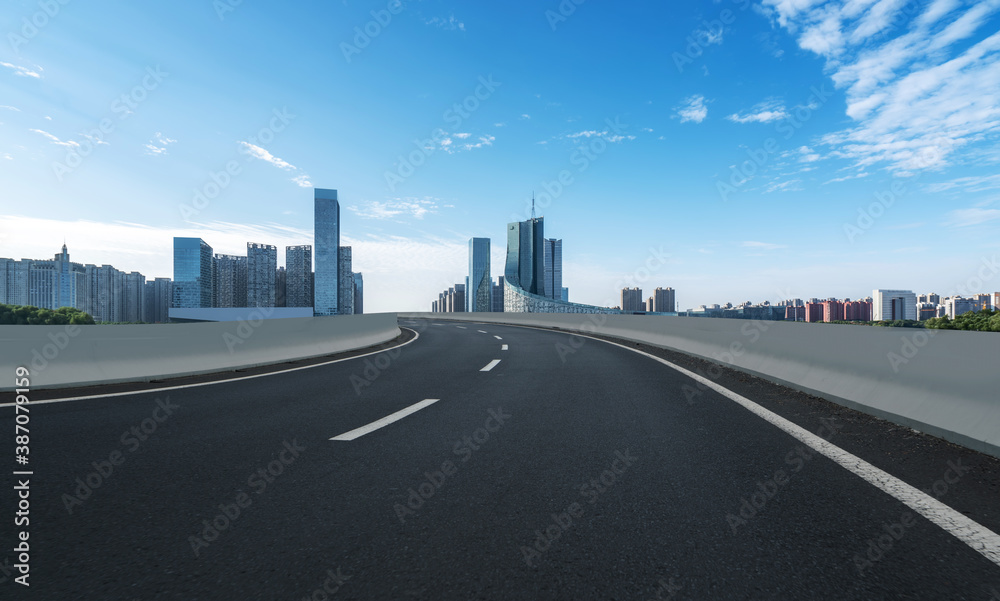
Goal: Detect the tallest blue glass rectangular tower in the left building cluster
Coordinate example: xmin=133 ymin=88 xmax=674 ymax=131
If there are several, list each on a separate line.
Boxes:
xmin=313 ymin=188 xmax=340 ymax=315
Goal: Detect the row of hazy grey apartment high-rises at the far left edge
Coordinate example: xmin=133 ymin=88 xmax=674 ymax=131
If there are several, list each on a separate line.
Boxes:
xmin=0 ymin=244 xmax=172 ymax=323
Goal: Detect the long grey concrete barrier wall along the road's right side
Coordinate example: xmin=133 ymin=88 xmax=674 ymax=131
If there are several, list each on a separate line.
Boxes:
xmin=400 ymin=313 xmax=1000 ymax=457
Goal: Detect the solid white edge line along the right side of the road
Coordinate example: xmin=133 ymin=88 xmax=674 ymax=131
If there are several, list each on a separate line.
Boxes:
xmin=568 ymin=328 xmax=1000 ymax=566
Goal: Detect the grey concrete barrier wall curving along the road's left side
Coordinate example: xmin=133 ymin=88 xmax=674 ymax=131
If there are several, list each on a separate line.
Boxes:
xmin=0 ymin=313 xmax=400 ymax=391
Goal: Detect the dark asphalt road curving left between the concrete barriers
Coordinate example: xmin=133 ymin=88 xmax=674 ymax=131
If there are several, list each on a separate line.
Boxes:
xmin=0 ymin=320 xmax=1000 ymax=601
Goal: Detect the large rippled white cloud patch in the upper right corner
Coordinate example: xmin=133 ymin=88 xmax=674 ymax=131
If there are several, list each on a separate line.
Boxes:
xmin=764 ymin=0 xmax=1000 ymax=176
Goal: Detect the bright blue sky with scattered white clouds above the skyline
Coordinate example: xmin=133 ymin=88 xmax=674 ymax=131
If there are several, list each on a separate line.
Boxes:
xmin=0 ymin=0 xmax=1000 ymax=312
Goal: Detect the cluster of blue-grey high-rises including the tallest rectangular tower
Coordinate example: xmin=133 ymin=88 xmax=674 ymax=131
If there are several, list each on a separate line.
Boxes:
xmin=172 ymin=188 xmax=364 ymax=315
